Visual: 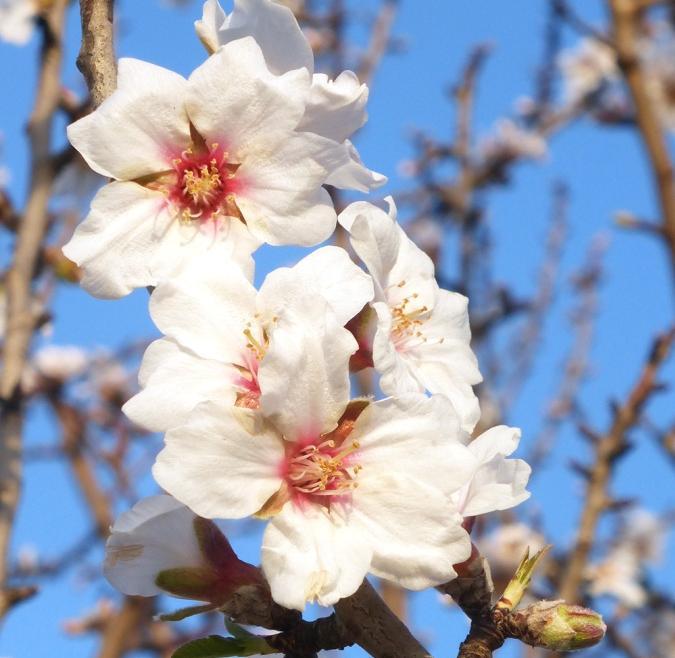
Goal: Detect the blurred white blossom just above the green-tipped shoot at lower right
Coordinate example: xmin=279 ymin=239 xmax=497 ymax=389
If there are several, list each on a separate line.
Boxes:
xmin=478 ymin=523 xmax=546 ymax=581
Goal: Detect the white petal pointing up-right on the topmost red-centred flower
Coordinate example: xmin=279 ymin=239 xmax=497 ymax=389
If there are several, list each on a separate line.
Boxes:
xmin=186 ymin=37 xmax=309 ymax=155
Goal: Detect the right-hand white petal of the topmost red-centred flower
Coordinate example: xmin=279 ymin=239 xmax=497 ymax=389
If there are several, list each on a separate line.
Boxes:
xmin=237 ymin=133 xmax=346 ymax=246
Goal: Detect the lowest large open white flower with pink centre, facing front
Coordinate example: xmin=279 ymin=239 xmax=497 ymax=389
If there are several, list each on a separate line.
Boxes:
xmin=153 ymin=314 xmax=475 ymax=610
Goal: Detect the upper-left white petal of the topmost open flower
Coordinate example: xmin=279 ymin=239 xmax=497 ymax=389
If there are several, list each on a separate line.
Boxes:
xmin=68 ymin=58 xmax=190 ymax=180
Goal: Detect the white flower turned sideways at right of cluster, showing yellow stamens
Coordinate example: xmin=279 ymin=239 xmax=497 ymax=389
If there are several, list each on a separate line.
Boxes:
xmin=339 ymin=197 xmax=481 ymax=432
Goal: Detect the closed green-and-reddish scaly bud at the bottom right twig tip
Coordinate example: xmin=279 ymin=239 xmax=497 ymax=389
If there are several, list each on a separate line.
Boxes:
xmin=513 ymin=601 xmax=607 ymax=651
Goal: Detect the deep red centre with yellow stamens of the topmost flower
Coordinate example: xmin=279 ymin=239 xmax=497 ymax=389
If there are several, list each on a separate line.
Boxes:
xmin=168 ymin=144 xmax=242 ymax=222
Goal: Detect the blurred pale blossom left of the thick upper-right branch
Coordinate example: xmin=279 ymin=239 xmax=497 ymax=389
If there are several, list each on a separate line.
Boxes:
xmin=558 ymin=38 xmax=619 ymax=104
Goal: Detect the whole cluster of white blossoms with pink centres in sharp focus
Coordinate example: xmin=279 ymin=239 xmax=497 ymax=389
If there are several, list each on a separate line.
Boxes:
xmin=64 ymin=0 xmax=530 ymax=610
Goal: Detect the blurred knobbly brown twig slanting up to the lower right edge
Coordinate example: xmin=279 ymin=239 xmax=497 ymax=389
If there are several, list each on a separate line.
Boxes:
xmin=559 ymin=328 xmax=675 ymax=601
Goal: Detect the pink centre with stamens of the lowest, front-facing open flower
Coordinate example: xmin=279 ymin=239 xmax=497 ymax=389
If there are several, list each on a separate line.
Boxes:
xmin=283 ymin=435 xmax=361 ymax=505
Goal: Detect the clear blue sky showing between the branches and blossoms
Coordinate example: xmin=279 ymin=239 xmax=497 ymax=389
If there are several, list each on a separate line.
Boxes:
xmin=0 ymin=0 xmax=675 ymax=658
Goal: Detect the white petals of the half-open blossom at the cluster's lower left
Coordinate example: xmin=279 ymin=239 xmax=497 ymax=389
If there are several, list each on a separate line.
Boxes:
xmin=103 ymin=495 xmax=203 ymax=596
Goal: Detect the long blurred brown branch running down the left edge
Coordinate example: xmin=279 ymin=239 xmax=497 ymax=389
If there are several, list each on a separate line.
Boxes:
xmin=0 ymin=0 xmax=68 ymax=618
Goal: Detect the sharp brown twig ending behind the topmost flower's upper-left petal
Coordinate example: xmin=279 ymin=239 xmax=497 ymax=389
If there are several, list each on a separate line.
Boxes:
xmin=77 ymin=0 xmax=117 ymax=107
